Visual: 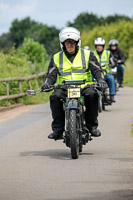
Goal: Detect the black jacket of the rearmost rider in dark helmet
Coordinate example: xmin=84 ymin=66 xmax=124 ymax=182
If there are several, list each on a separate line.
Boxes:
xmin=108 ymin=47 xmax=125 ymax=64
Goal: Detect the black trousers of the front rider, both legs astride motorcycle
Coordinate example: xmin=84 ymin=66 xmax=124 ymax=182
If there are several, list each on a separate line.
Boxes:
xmin=50 ymin=88 xmax=98 ymax=134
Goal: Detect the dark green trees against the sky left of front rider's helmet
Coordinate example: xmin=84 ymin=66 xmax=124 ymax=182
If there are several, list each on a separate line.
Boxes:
xmin=0 ymin=17 xmax=60 ymax=55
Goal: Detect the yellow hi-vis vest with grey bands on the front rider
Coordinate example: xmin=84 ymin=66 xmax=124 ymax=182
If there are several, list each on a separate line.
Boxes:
xmin=54 ymin=49 xmax=93 ymax=87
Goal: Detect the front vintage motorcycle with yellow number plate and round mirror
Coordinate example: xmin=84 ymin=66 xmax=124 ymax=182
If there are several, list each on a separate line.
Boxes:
xmin=27 ymin=79 xmax=101 ymax=159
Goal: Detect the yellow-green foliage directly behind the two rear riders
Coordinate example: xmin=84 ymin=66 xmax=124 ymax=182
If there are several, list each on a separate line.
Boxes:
xmin=81 ymin=20 xmax=133 ymax=58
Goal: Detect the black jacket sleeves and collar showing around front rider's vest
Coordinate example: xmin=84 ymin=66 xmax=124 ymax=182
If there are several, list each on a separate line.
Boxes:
xmin=45 ymin=49 xmax=104 ymax=85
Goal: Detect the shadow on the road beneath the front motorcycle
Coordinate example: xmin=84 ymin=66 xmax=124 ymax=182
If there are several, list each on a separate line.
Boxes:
xmin=20 ymin=149 xmax=93 ymax=160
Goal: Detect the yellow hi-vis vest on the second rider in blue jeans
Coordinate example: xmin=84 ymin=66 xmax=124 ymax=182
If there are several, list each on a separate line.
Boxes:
xmin=94 ymin=50 xmax=112 ymax=75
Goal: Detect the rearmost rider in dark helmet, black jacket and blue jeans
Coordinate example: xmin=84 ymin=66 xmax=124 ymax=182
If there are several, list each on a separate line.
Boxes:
xmin=108 ymin=39 xmax=125 ymax=87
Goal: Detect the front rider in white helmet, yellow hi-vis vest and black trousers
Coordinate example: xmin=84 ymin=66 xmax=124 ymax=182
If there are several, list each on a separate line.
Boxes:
xmin=41 ymin=27 xmax=107 ymax=140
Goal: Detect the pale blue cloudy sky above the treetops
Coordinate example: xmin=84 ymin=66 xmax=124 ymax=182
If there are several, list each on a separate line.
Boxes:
xmin=0 ymin=0 xmax=133 ymax=35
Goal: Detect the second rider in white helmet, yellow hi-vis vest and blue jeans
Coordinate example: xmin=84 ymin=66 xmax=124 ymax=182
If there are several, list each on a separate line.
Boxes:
xmin=94 ymin=37 xmax=116 ymax=102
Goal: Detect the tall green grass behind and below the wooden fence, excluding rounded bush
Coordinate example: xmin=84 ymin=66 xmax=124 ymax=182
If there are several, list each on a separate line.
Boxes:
xmin=0 ymin=49 xmax=50 ymax=106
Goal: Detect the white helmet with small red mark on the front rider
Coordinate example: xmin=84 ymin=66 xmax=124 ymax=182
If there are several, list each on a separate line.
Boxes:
xmin=59 ymin=27 xmax=81 ymax=49
